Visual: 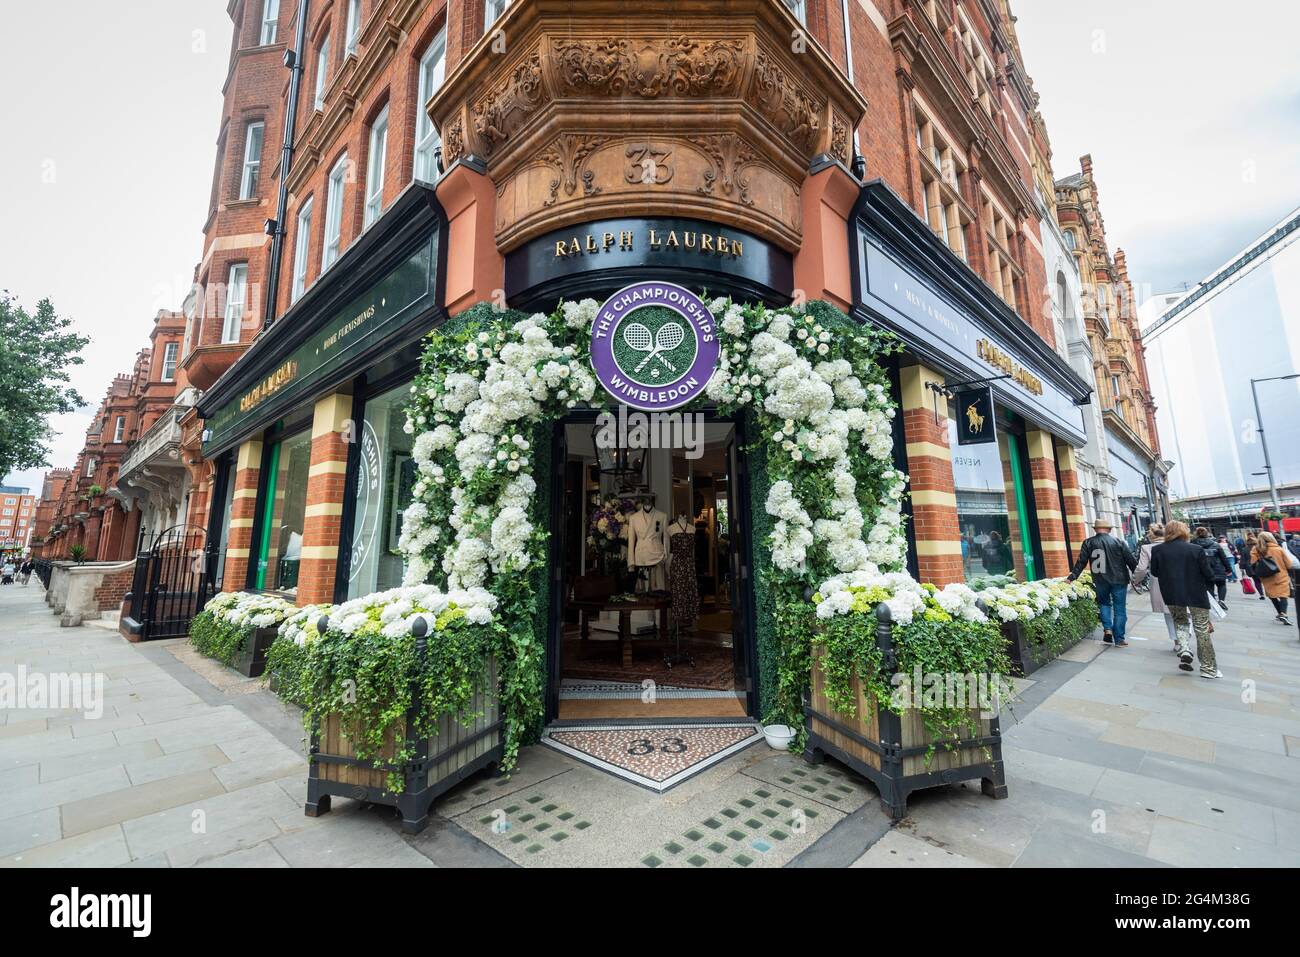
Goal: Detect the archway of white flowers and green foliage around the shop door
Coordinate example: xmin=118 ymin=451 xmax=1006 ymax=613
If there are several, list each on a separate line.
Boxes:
xmin=399 ymin=299 xmax=906 ymax=762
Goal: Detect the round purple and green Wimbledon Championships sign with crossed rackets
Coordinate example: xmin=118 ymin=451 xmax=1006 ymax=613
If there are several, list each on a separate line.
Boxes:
xmin=592 ymin=282 xmax=719 ymax=412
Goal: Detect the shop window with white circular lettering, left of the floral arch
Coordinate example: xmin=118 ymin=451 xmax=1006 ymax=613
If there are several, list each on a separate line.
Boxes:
xmin=347 ymin=384 xmax=416 ymax=598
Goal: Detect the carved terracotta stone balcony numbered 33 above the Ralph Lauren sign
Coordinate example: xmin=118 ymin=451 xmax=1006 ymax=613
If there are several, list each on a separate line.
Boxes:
xmin=429 ymin=0 xmax=867 ymax=252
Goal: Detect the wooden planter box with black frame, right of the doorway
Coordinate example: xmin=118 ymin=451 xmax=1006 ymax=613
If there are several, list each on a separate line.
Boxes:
xmin=803 ymin=605 xmax=1008 ymax=820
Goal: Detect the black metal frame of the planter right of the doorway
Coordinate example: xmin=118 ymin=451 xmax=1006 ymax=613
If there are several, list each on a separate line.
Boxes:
xmin=803 ymin=603 xmax=1008 ymax=820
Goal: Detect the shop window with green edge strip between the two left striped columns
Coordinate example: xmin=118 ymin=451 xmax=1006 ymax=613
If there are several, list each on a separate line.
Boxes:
xmin=256 ymin=430 xmax=312 ymax=594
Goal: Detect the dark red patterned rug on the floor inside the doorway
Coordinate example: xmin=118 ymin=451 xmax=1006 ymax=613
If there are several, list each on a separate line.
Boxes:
xmin=564 ymin=638 xmax=736 ymax=692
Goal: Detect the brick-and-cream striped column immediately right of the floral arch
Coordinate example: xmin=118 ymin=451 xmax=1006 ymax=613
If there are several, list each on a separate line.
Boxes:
xmin=898 ymin=365 xmax=966 ymax=585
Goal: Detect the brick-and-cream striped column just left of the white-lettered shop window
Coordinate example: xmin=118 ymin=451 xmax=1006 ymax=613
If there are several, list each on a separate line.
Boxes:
xmin=298 ymin=393 xmax=355 ymax=606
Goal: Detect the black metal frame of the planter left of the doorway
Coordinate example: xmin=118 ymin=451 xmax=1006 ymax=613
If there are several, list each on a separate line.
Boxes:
xmin=303 ymin=620 xmax=506 ymax=833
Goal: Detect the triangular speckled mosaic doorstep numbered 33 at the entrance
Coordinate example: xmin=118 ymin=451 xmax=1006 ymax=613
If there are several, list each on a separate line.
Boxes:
xmin=542 ymin=723 xmax=763 ymax=794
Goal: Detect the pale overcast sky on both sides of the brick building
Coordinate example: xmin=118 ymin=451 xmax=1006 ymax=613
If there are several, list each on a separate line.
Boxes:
xmin=0 ymin=0 xmax=1300 ymax=492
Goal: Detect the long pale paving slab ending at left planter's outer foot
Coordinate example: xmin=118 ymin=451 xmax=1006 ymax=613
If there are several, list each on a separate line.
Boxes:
xmin=122 ymin=779 xmax=303 ymax=857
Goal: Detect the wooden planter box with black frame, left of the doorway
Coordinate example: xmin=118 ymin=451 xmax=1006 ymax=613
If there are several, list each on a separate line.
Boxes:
xmin=304 ymin=662 xmax=504 ymax=833
